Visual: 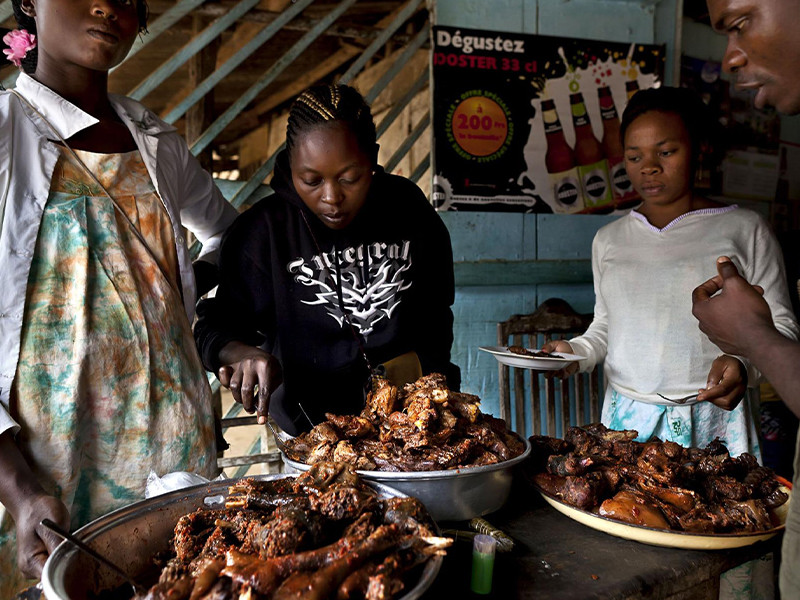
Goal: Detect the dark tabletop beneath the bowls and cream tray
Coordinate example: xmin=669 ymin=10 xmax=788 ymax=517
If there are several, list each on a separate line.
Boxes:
xmin=423 ymin=482 xmax=781 ymax=600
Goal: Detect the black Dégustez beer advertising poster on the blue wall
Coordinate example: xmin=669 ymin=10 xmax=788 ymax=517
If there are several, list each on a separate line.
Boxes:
xmin=432 ymin=26 xmax=664 ymax=214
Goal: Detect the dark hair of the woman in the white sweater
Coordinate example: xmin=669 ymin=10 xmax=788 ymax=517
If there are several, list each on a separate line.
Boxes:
xmin=619 ymin=86 xmax=723 ymax=177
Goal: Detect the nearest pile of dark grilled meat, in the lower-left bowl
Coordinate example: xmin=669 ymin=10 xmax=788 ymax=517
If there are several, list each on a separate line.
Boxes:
xmin=137 ymin=463 xmax=451 ymax=600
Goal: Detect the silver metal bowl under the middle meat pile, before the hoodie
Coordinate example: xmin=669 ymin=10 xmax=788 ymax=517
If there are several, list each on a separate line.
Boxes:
xmin=282 ymin=438 xmax=531 ymax=521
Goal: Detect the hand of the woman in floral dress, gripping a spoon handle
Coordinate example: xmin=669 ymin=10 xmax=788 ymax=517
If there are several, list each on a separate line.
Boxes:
xmin=14 ymin=493 xmax=69 ymax=579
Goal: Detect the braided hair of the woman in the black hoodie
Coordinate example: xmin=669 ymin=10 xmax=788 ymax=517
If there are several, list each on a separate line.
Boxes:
xmin=286 ymin=85 xmax=378 ymax=166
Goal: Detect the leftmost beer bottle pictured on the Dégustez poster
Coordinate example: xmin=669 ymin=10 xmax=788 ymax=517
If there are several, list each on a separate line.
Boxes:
xmin=542 ymin=100 xmax=584 ymax=213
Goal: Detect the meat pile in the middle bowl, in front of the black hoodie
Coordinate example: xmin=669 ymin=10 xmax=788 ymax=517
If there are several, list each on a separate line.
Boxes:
xmin=286 ymin=373 xmax=525 ymax=471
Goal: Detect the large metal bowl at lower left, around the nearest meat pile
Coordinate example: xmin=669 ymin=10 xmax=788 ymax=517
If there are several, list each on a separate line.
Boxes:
xmin=42 ymin=474 xmax=442 ymax=600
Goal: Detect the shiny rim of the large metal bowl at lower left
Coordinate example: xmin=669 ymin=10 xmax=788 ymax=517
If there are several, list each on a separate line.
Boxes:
xmin=42 ymin=473 xmax=444 ymax=600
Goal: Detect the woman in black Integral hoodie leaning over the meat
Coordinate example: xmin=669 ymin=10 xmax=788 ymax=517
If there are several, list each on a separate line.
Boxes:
xmin=195 ymin=85 xmax=460 ymax=434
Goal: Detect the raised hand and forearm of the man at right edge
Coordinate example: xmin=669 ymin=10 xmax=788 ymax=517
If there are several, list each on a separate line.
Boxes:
xmin=692 ymin=256 xmax=800 ymax=416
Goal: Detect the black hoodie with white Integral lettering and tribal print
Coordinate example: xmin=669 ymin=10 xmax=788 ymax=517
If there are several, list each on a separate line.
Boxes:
xmin=195 ymin=151 xmax=460 ymax=434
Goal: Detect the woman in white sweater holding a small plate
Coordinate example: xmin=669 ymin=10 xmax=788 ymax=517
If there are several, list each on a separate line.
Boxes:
xmin=545 ymin=88 xmax=798 ymax=458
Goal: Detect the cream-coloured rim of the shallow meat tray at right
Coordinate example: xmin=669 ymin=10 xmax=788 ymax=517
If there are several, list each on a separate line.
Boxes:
xmin=534 ymin=479 xmax=792 ymax=550
